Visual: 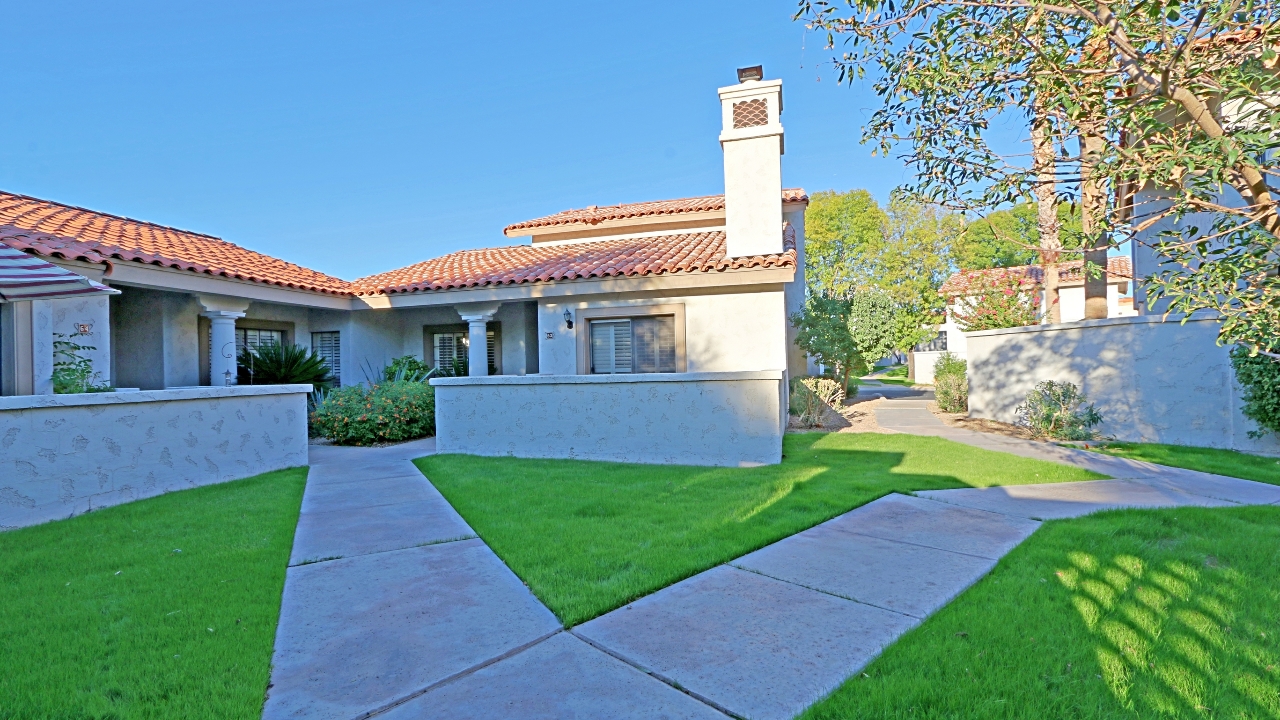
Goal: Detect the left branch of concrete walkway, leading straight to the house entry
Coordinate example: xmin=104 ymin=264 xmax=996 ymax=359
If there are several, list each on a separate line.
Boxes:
xmin=262 ymin=439 xmax=723 ymax=720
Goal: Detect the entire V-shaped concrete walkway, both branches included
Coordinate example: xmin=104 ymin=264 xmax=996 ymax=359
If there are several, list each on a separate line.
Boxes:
xmin=264 ymin=420 xmax=1280 ymax=720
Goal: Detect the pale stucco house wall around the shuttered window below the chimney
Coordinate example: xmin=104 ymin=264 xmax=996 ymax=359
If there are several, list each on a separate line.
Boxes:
xmin=538 ymin=290 xmax=787 ymax=375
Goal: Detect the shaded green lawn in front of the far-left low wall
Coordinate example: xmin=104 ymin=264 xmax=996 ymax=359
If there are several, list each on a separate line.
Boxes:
xmin=0 ymin=468 xmax=307 ymax=720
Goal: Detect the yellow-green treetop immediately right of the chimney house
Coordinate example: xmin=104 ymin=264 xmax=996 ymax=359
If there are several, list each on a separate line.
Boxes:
xmin=804 ymin=190 xmax=887 ymax=297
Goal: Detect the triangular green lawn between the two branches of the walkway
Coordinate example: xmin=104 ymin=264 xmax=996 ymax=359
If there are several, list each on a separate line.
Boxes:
xmin=416 ymin=433 xmax=1100 ymax=625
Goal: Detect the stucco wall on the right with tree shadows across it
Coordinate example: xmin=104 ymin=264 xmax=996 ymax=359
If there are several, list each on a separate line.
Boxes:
xmin=966 ymin=315 xmax=1280 ymax=454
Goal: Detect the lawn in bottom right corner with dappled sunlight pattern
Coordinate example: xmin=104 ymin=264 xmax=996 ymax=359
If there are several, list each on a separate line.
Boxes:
xmin=803 ymin=507 xmax=1280 ymax=720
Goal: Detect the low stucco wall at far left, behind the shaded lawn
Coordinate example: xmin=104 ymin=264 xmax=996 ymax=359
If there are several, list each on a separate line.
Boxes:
xmin=0 ymin=384 xmax=311 ymax=529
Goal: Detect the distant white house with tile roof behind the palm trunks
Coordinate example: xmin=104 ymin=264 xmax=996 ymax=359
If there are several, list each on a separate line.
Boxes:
xmin=910 ymin=256 xmax=1138 ymax=384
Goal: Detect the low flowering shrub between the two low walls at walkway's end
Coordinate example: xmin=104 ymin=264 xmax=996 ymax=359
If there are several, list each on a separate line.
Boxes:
xmin=311 ymin=380 xmax=435 ymax=445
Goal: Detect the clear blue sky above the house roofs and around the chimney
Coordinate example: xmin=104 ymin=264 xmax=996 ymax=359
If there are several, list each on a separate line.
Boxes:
xmin=0 ymin=1 xmax=993 ymax=279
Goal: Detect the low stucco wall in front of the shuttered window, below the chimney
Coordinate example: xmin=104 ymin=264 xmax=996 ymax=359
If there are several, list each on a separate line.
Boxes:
xmin=431 ymin=370 xmax=783 ymax=466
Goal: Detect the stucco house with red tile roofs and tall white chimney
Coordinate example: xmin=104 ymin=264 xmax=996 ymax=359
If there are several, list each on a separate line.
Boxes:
xmin=0 ymin=68 xmax=808 ymax=461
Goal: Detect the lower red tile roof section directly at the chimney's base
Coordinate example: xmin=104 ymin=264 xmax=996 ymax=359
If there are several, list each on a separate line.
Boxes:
xmin=353 ymin=231 xmax=796 ymax=295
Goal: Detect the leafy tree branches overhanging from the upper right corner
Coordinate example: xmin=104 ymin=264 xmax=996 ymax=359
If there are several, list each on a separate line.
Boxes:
xmin=796 ymin=0 xmax=1280 ymax=351
